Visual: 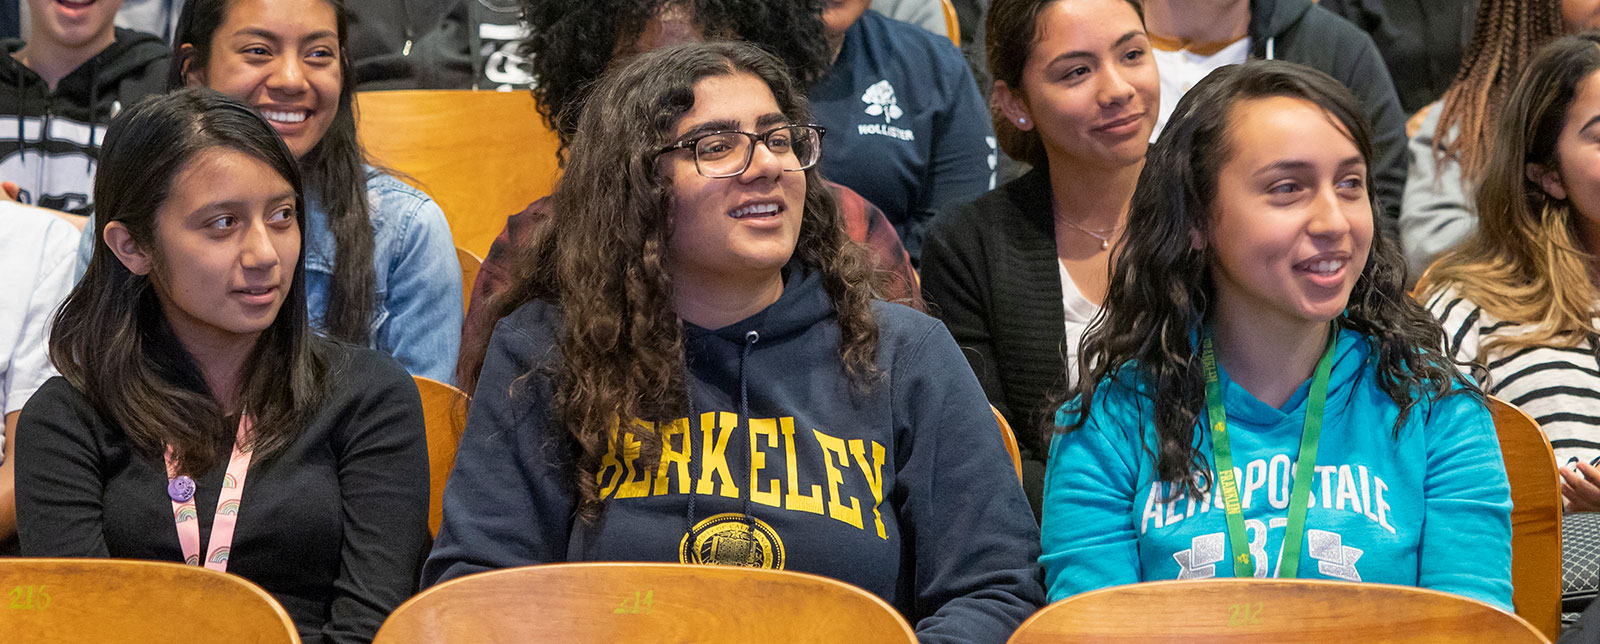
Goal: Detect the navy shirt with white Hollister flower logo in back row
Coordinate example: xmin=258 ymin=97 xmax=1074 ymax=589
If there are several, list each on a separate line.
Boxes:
xmin=810 ymin=10 xmax=997 ymax=260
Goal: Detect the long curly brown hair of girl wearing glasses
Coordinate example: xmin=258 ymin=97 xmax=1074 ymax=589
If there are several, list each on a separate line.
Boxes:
xmin=458 ymin=42 xmax=878 ymax=521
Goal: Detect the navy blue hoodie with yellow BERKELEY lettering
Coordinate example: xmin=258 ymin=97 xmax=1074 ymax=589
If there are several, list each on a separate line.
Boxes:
xmin=422 ymin=268 xmax=1043 ymax=644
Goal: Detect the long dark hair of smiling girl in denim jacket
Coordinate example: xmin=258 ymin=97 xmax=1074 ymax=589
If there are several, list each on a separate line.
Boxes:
xmin=166 ymin=0 xmax=378 ymax=346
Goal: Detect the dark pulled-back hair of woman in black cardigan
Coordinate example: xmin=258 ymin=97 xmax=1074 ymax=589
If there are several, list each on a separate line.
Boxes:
xmin=984 ymin=0 xmax=1144 ymax=167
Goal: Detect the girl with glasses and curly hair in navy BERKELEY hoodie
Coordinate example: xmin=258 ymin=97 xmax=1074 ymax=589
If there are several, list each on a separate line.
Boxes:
xmin=424 ymin=43 xmax=1043 ymax=644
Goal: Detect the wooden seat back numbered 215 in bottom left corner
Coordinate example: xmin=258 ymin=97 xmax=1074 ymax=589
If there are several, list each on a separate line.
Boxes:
xmin=0 ymin=559 xmax=301 ymax=644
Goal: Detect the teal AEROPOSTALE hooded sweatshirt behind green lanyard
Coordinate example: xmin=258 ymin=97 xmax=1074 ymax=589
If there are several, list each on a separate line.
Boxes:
xmin=1040 ymin=330 xmax=1510 ymax=610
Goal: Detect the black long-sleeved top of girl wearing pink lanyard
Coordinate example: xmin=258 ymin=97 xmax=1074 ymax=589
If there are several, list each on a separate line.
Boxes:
xmin=16 ymin=343 xmax=429 ymax=644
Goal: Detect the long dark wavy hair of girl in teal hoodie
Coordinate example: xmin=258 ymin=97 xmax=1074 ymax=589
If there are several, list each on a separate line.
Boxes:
xmin=1058 ymin=61 xmax=1458 ymax=495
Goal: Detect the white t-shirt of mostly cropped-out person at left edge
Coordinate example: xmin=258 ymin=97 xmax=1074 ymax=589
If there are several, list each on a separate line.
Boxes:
xmin=0 ymin=202 xmax=78 ymax=458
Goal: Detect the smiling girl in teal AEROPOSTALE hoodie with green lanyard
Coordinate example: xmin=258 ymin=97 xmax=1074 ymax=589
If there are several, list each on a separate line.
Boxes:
xmin=1040 ymin=61 xmax=1510 ymax=609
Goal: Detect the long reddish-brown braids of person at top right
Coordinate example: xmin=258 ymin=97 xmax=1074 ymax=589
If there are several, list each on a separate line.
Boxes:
xmin=1434 ymin=0 xmax=1562 ymax=183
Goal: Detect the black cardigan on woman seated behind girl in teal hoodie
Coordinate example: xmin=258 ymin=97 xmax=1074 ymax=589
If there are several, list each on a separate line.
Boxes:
xmin=922 ymin=168 xmax=1067 ymax=511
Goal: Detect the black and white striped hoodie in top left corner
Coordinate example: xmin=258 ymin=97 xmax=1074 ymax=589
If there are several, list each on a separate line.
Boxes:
xmin=0 ymin=29 xmax=171 ymax=215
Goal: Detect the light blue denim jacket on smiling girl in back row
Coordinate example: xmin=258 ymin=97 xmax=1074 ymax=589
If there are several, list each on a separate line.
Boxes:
xmin=78 ymin=168 xmax=462 ymax=384
